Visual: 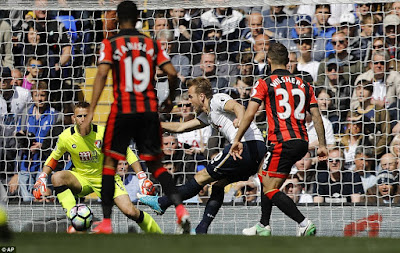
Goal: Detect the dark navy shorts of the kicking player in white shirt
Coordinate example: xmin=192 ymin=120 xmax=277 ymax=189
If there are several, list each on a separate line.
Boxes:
xmin=206 ymin=141 xmax=267 ymax=183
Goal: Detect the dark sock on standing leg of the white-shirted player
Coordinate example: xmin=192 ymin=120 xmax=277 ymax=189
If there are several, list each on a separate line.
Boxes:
xmin=196 ymin=186 xmax=224 ymax=234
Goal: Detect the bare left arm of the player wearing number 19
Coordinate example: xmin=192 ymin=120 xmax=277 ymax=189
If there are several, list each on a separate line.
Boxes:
xmin=79 ymin=64 xmax=111 ymax=136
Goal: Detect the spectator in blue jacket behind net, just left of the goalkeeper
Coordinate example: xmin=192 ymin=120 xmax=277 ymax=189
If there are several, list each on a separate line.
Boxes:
xmin=16 ymin=81 xmax=61 ymax=201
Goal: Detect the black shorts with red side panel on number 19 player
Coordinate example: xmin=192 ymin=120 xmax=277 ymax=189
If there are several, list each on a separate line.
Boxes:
xmin=103 ymin=112 xmax=163 ymax=161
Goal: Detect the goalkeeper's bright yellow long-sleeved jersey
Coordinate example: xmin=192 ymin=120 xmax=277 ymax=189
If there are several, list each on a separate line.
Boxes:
xmin=45 ymin=124 xmax=138 ymax=177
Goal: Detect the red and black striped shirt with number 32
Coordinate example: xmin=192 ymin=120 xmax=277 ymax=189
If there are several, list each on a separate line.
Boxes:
xmin=251 ymin=69 xmax=318 ymax=142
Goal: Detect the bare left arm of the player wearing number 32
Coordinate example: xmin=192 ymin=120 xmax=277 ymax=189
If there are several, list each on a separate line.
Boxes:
xmin=229 ymin=101 xmax=260 ymax=160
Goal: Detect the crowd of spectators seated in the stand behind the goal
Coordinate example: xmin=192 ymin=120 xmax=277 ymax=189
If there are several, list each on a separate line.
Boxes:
xmin=0 ymin=2 xmax=400 ymax=204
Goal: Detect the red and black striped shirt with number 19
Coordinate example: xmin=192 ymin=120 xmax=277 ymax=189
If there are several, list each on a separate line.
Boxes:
xmin=99 ymin=29 xmax=170 ymax=113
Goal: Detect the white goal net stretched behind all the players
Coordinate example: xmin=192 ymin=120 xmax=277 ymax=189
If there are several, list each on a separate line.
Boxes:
xmin=0 ymin=0 xmax=400 ymax=237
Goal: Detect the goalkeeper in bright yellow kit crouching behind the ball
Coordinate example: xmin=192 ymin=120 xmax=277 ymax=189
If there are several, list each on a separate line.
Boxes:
xmin=33 ymin=102 xmax=162 ymax=233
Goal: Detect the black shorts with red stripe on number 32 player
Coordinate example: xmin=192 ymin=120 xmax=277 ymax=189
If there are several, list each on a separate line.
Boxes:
xmin=262 ymin=139 xmax=308 ymax=178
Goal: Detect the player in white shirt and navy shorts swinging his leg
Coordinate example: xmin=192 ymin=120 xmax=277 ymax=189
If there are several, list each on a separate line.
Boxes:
xmin=139 ymin=77 xmax=267 ymax=234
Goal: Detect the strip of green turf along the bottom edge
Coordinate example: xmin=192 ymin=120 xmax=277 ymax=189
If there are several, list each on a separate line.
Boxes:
xmin=0 ymin=233 xmax=400 ymax=253
